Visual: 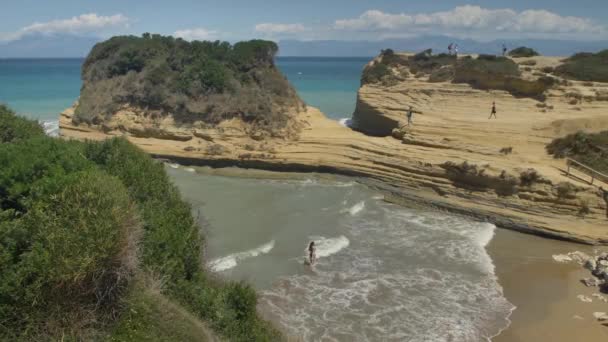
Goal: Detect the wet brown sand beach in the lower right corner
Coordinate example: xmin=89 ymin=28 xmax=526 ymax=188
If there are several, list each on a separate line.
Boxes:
xmin=488 ymin=229 xmax=608 ymax=342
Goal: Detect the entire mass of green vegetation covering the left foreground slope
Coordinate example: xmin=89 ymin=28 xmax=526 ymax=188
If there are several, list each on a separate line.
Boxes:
xmin=0 ymin=107 xmax=282 ymax=341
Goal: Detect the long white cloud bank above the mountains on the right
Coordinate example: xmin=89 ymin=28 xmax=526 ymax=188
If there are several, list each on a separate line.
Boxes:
xmin=333 ymin=5 xmax=608 ymax=38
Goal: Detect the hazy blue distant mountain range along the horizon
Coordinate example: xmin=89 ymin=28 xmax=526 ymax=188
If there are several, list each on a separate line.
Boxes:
xmin=0 ymin=35 xmax=608 ymax=58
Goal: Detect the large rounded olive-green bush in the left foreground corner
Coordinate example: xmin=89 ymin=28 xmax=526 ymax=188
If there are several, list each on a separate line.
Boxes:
xmin=0 ymin=170 xmax=140 ymax=337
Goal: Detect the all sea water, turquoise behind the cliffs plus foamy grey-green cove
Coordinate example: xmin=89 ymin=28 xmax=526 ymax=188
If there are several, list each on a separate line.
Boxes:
xmin=0 ymin=57 xmax=514 ymax=341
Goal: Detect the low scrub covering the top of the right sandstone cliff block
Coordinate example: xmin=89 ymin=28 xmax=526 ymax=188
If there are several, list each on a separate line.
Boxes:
xmin=361 ymin=49 xmax=555 ymax=99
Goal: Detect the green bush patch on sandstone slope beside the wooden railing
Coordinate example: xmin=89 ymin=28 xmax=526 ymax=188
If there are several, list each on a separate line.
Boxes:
xmin=547 ymin=131 xmax=608 ymax=174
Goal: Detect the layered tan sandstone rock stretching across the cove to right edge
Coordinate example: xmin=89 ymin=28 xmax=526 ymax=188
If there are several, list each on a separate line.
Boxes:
xmin=60 ymin=50 xmax=608 ymax=244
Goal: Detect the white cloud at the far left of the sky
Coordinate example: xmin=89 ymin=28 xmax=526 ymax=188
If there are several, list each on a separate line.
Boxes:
xmin=0 ymin=13 xmax=130 ymax=41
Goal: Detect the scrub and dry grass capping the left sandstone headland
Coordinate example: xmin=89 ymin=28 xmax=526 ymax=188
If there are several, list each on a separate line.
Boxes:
xmin=74 ymin=34 xmax=302 ymax=134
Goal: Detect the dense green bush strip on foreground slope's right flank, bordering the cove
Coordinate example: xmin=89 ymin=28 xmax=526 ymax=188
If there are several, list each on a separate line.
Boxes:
xmin=85 ymin=138 xmax=202 ymax=281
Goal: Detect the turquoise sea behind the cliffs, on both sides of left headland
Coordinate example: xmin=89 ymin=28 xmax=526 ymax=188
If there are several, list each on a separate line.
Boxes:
xmin=0 ymin=57 xmax=370 ymax=121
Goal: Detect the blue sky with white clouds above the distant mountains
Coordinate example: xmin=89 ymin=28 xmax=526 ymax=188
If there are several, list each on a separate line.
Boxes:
xmin=0 ymin=0 xmax=608 ymax=43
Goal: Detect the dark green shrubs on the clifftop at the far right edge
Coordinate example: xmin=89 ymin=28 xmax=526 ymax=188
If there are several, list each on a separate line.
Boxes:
xmin=555 ymin=50 xmax=608 ymax=82
